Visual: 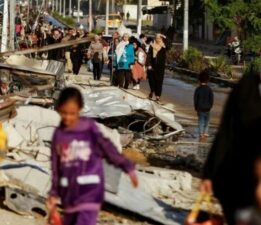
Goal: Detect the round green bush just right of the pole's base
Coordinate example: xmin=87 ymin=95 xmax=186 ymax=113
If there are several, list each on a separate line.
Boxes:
xmin=183 ymin=48 xmax=204 ymax=72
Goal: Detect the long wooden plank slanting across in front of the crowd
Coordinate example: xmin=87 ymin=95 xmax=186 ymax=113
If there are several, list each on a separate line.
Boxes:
xmin=0 ymin=38 xmax=91 ymax=57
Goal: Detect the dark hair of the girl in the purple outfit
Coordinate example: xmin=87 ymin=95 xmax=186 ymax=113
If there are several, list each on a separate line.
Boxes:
xmin=56 ymin=87 xmax=84 ymax=109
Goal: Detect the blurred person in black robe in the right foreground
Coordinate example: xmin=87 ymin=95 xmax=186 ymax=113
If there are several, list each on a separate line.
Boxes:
xmin=201 ymin=60 xmax=261 ymax=225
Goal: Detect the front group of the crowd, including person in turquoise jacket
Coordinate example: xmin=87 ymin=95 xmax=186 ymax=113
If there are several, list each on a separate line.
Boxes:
xmin=88 ymin=32 xmax=166 ymax=101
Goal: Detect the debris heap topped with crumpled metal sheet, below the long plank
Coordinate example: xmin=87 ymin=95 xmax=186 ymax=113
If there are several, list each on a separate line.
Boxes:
xmin=0 ymin=55 xmax=64 ymax=99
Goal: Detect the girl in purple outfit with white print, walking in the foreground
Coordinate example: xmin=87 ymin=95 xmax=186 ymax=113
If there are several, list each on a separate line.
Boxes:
xmin=47 ymin=88 xmax=138 ymax=225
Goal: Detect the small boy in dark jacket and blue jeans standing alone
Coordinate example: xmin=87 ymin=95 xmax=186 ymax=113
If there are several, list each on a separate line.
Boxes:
xmin=194 ymin=70 xmax=214 ymax=139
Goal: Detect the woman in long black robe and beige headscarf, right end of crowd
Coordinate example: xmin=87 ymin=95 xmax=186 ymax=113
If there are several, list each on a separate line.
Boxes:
xmin=147 ymin=34 xmax=166 ymax=101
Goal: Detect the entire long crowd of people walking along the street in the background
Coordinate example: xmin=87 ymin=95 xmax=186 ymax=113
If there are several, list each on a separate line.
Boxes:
xmin=15 ymin=10 xmax=166 ymax=101
